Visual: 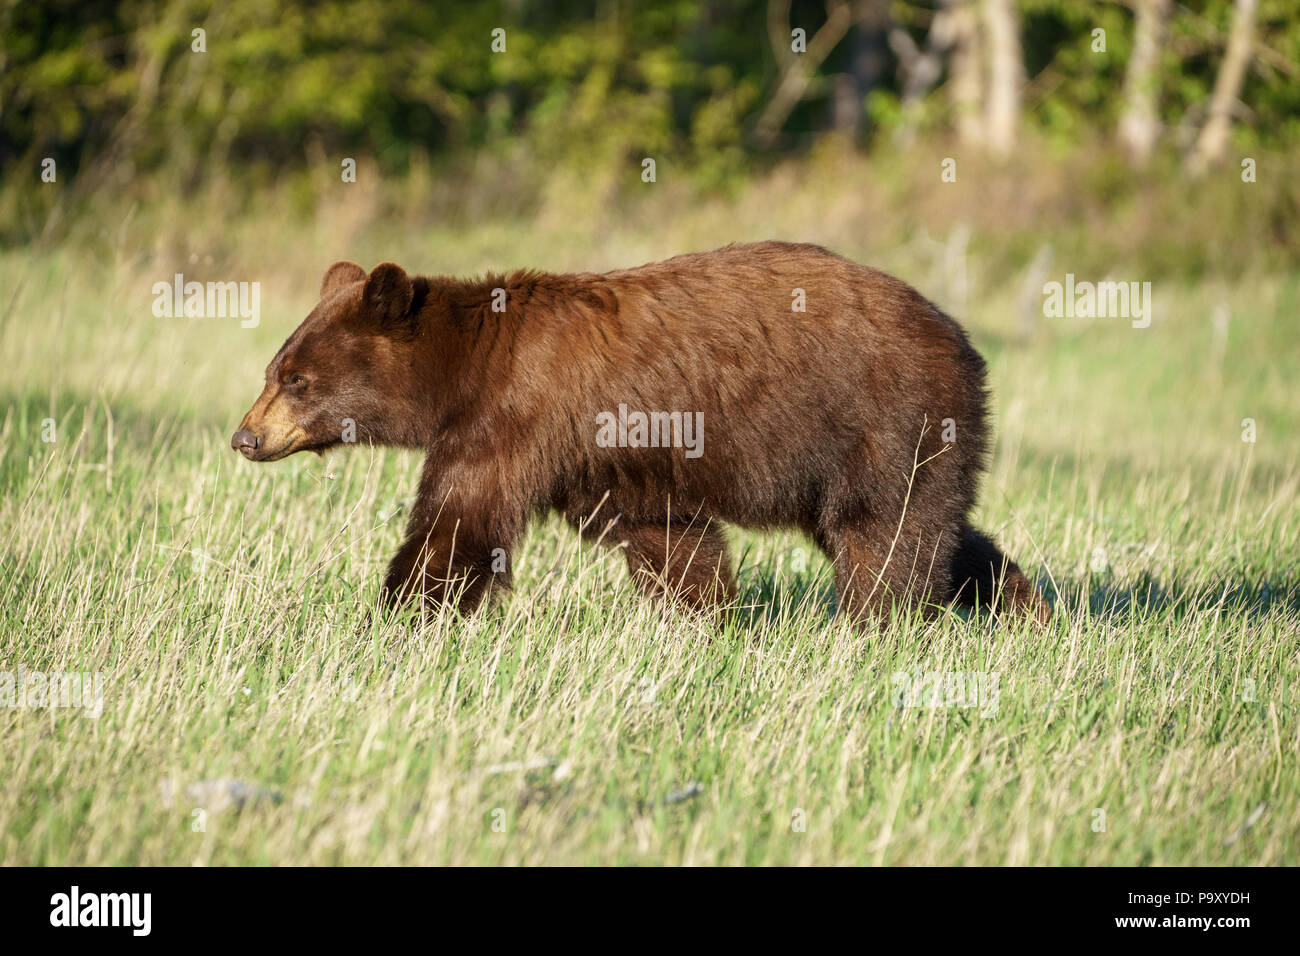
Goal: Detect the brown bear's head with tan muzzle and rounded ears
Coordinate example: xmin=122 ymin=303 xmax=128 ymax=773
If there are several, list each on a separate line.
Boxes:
xmin=230 ymin=263 xmax=423 ymax=462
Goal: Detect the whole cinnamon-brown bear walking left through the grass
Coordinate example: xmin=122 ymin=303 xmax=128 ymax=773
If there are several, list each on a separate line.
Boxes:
xmin=230 ymin=242 xmax=1052 ymax=624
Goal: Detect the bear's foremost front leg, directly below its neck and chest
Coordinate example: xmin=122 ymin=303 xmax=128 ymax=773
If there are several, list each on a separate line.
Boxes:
xmin=384 ymin=455 xmax=525 ymax=614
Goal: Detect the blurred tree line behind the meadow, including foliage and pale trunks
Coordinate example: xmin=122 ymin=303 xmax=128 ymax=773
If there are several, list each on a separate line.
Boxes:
xmin=0 ymin=0 xmax=1300 ymax=188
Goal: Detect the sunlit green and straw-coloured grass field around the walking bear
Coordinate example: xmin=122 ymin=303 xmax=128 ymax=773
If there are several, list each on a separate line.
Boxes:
xmin=0 ymin=164 xmax=1300 ymax=865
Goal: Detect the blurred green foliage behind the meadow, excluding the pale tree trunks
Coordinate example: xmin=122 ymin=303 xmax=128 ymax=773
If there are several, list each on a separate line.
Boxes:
xmin=0 ymin=0 xmax=1300 ymax=195
